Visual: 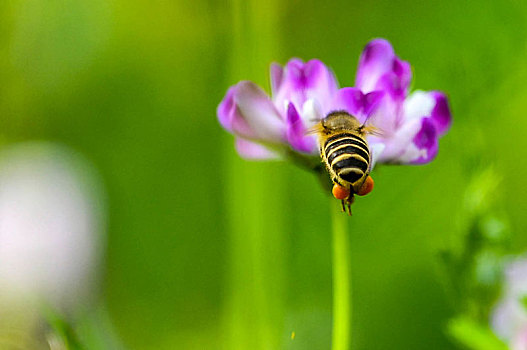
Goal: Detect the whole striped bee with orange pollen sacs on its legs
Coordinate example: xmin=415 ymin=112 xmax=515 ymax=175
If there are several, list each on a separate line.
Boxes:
xmin=311 ymin=111 xmax=376 ymax=215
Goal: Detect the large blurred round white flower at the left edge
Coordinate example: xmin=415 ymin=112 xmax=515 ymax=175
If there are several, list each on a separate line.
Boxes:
xmin=0 ymin=142 xmax=104 ymax=311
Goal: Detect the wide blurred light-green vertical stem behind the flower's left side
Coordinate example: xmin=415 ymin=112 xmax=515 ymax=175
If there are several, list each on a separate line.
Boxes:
xmin=221 ymin=0 xmax=287 ymax=350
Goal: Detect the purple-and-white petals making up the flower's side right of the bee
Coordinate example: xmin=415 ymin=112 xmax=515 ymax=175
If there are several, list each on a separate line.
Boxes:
xmin=356 ymin=39 xmax=451 ymax=164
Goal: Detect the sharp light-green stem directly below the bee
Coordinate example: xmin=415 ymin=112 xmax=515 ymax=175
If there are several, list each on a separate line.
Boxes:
xmin=330 ymin=199 xmax=352 ymax=350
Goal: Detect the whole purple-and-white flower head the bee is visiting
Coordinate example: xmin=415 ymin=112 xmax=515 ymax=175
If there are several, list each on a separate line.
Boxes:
xmin=217 ymin=39 xmax=451 ymax=168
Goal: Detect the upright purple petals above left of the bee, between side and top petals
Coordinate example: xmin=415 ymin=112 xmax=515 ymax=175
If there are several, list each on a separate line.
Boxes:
xmin=272 ymin=58 xmax=338 ymax=114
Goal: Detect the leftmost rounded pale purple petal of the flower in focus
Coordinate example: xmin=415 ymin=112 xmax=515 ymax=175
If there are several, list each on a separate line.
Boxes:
xmin=217 ymin=81 xmax=285 ymax=143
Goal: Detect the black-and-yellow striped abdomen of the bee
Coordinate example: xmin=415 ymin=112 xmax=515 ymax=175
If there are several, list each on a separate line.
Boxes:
xmin=323 ymin=133 xmax=370 ymax=186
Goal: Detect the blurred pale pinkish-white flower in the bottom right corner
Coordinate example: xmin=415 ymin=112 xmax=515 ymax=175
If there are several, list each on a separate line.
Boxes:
xmin=491 ymin=257 xmax=527 ymax=350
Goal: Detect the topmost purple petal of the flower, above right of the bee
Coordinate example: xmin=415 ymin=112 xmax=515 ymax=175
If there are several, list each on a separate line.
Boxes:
xmin=355 ymin=39 xmax=412 ymax=97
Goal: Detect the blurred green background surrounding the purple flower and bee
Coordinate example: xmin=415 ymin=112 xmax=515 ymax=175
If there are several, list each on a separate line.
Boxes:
xmin=0 ymin=0 xmax=527 ymax=349
